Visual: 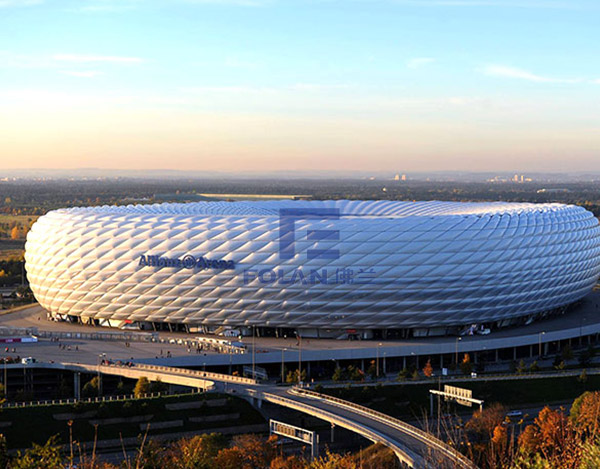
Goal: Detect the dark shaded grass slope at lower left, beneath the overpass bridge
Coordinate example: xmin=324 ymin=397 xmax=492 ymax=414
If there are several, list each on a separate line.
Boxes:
xmin=0 ymin=394 xmax=264 ymax=448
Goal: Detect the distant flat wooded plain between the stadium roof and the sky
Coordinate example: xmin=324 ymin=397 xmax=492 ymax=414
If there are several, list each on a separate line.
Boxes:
xmin=0 ymin=178 xmax=600 ymax=216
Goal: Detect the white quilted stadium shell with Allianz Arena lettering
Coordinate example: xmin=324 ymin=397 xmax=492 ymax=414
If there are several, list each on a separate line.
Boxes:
xmin=25 ymin=200 xmax=600 ymax=337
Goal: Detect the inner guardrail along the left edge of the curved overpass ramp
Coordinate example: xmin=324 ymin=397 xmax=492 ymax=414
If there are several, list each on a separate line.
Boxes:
xmin=257 ymin=393 xmax=421 ymax=467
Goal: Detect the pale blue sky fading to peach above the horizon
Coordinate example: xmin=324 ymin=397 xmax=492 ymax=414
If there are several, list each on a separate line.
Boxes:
xmin=0 ymin=0 xmax=600 ymax=173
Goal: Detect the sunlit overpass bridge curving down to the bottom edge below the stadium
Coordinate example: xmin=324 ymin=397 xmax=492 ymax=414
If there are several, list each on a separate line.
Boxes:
xmin=5 ymin=362 xmax=476 ymax=469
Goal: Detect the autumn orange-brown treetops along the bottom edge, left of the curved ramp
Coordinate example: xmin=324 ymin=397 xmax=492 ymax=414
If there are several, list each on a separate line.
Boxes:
xmin=0 ymin=433 xmax=400 ymax=469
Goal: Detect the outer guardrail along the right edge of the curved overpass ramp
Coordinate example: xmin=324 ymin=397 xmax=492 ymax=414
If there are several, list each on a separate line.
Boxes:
xmin=289 ymin=387 xmax=477 ymax=469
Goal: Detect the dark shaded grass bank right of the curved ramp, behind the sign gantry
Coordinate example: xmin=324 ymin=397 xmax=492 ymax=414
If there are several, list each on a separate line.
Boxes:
xmin=322 ymin=375 xmax=600 ymax=418
